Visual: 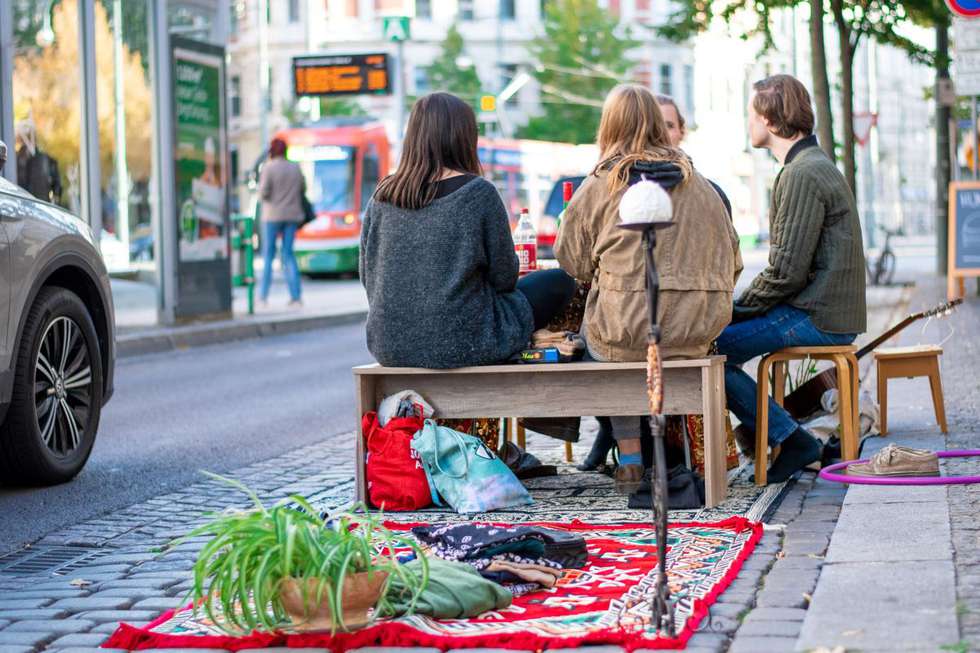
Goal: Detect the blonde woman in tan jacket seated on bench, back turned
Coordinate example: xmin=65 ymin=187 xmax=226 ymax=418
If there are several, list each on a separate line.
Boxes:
xmin=555 ymin=84 xmax=742 ymax=493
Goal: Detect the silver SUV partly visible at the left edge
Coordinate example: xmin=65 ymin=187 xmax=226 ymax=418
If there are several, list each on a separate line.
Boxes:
xmin=0 ymin=142 xmax=115 ymax=485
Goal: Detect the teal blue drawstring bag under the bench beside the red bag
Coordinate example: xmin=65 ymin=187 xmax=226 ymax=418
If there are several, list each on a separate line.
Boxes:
xmin=412 ymin=419 xmax=533 ymax=513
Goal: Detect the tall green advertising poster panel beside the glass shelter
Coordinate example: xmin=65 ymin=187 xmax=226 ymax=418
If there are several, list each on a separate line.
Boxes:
xmin=171 ymin=36 xmax=231 ymax=318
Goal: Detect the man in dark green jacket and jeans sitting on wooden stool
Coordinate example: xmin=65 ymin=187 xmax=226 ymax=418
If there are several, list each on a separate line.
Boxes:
xmin=718 ymin=75 xmax=866 ymax=483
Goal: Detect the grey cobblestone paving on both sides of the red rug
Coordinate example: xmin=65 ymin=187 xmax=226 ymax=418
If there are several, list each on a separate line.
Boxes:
xmin=0 ymin=286 xmax=912 ymax=653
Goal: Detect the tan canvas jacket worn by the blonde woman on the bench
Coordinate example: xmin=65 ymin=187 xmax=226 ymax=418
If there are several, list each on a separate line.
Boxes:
xmin=555 ymin=171 xmax=742 ymax=361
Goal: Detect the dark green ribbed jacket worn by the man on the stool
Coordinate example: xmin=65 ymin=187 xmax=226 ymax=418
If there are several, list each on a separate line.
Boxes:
xmin=734 ymin=136 xmax=867 ymax=333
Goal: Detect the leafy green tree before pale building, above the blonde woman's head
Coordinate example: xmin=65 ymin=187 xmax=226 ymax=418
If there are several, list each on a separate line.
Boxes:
xmin=521 ymin=0 xmax=638 ymax=144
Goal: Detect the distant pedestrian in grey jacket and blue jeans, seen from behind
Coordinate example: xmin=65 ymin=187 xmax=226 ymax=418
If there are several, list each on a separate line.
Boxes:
xmin=259 ymin=138 xmax=306 ymax=306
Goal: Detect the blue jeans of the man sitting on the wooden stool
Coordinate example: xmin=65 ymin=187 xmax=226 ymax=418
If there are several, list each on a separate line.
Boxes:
xmin=718 ymin=304 xmax=857 ymax=446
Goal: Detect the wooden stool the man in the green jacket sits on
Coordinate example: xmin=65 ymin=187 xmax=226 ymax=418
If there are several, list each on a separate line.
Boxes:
xmin=755 ymin=345 xmax=860 ymax=485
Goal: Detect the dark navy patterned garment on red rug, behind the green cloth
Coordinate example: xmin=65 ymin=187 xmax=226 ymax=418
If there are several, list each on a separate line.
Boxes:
xmin=412 ymin=523 xmax=587 ymax=569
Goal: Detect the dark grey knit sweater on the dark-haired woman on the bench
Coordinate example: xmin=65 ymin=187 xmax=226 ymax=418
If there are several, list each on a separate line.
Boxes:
xmin=360 ymin=177 xmax=534 ymax=368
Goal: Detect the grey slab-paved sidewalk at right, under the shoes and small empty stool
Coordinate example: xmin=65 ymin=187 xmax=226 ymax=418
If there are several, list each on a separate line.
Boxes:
xmin=795 ymin=278 xmax=980 ymax=651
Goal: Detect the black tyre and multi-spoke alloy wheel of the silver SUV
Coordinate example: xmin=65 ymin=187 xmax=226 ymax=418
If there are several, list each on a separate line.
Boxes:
xmin=0 ymin=287 xmax=103 ymax=485
